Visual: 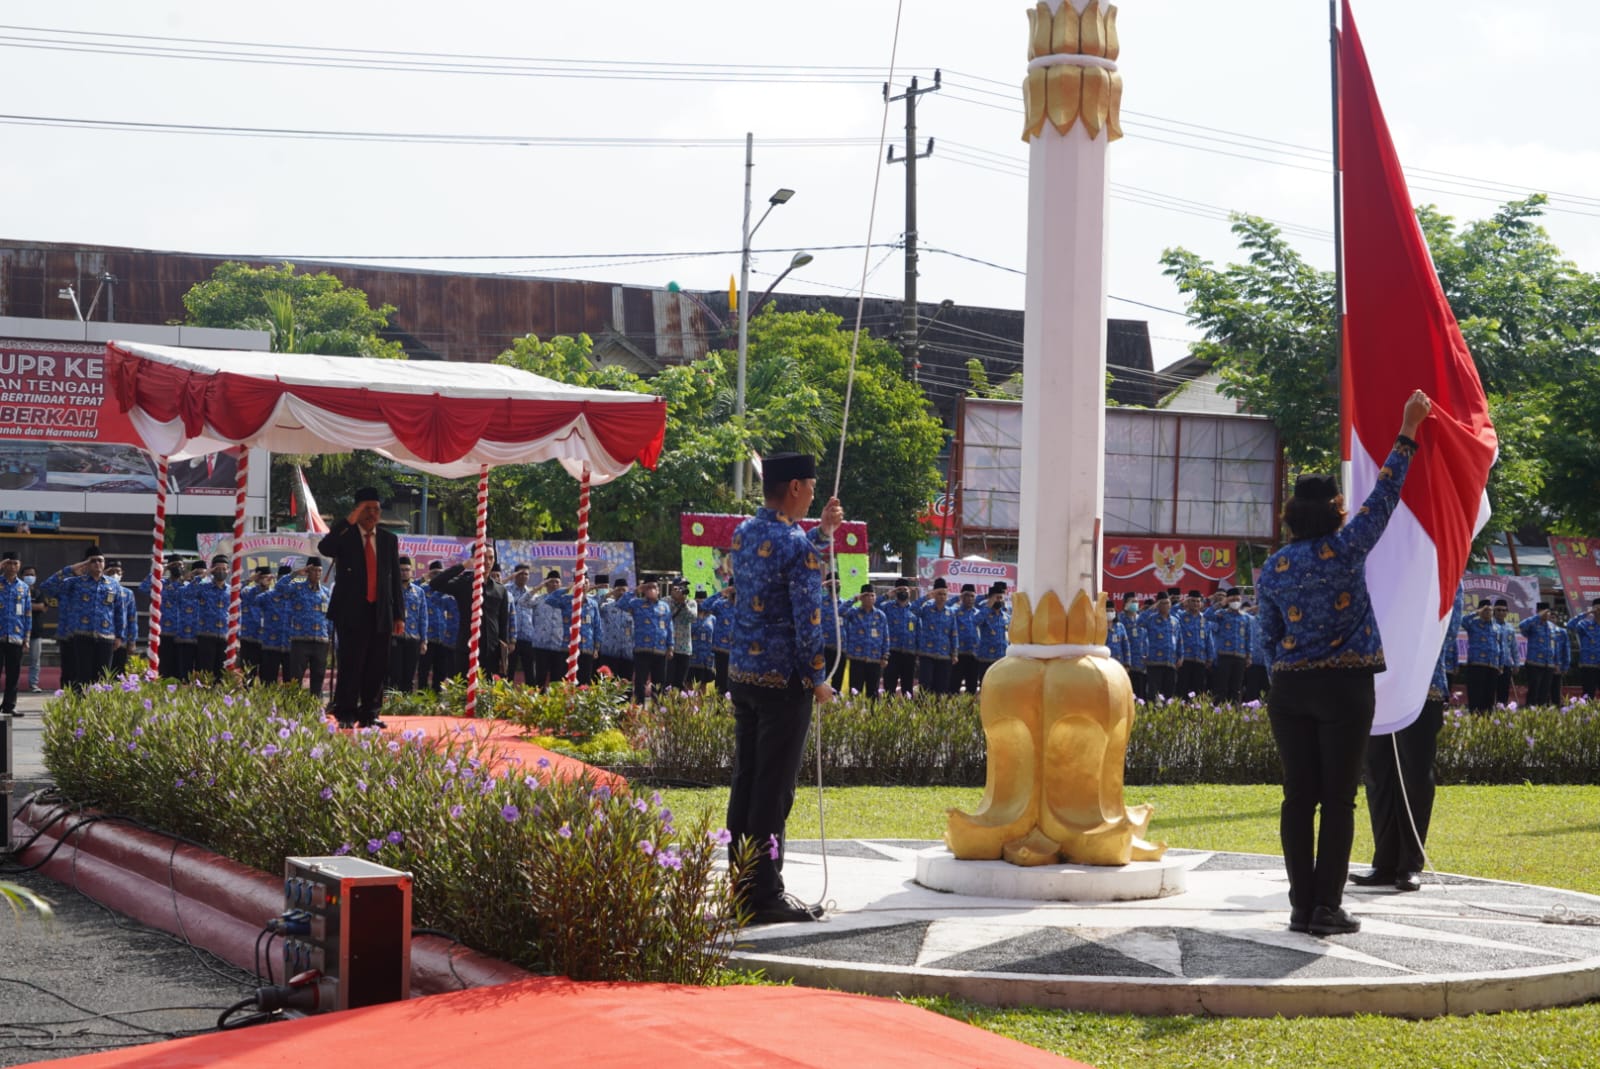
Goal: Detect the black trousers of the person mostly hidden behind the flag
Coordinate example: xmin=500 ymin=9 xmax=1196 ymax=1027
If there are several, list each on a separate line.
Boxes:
xmin=1366 ymin=699 xmax=1445 ymax=875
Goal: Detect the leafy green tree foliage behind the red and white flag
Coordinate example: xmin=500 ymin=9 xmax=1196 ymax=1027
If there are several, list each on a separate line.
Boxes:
xmin=1162 ymin=195 xmax=1600 ymax=544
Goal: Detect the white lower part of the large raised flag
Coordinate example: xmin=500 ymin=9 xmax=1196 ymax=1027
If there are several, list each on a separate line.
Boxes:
xmin=1346 ymin=424 xmax=1490 ymax=735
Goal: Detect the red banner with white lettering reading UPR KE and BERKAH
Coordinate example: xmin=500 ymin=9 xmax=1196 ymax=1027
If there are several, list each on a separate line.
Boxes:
xmin=0 ymin=341 xmax=139 ymax=445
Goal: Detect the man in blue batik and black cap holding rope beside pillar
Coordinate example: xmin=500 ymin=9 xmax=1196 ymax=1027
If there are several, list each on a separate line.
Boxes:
xmin=728 ymin=453 xmax=845 ymax=923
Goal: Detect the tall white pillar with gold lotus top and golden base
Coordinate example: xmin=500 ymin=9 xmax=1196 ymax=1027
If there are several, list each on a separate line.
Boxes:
xmin=944 ymin=0 xmax=1165 ymax=866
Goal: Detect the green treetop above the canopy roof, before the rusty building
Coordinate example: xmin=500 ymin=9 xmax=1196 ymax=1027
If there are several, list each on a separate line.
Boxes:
xmin=184 ymin=261 xmax=405 ymax=358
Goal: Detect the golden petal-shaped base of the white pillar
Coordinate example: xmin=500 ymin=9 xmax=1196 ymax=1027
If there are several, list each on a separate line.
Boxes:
xmin=944 ymin=591 xmax=1166 ymax=866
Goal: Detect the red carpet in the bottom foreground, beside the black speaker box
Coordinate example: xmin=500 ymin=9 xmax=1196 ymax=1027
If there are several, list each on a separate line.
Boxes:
xmin=32 ymin=979 xmax=1083 ymax=1069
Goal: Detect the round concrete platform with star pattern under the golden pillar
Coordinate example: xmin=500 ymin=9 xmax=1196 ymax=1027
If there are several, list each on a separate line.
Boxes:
xmin=736 ymin=840 xmax=1600 ymax=1018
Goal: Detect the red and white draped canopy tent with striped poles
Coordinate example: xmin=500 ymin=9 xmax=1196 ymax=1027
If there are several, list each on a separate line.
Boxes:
xmin=106 ymin=341 xmax=667 ymax=715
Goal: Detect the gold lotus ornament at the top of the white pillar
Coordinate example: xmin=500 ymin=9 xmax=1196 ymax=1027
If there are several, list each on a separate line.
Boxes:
xmin=1022 ymin=0 xmax=1122 ymax=141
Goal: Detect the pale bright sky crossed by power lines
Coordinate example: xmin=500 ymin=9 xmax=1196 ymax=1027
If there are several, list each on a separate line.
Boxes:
xmin=0 ymin=0 xmax=1600 ymax=366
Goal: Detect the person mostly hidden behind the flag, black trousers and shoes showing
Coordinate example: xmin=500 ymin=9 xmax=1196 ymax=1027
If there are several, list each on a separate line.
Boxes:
xmin=1350 ymin=586 xmax=1466 ymax=891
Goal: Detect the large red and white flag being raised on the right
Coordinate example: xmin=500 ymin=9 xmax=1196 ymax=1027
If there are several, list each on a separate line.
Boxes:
xmin=1338 ymin=0 xmax=1499 ymax=735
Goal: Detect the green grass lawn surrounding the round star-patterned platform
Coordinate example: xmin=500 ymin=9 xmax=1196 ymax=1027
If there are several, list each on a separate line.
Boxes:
xmin=664 ymin=786 xmax=1600 ymax=1069
